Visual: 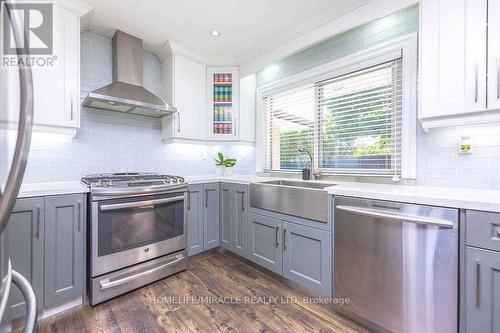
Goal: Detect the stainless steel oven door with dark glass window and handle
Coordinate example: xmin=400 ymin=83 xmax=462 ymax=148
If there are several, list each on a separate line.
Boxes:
xmin=91 ymin=191 xmax=187 ymax=277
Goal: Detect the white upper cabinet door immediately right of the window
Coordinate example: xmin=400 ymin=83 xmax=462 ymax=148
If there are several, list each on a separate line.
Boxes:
xmin=419 ymin=0 xmax=486 ymax=129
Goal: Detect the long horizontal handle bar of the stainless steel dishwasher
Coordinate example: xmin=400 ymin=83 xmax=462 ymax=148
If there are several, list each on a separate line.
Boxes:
xmin=336 ymin=205 xmax=453 ymax=229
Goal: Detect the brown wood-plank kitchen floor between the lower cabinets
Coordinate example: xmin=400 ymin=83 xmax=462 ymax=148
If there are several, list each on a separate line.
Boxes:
xmin=32 ymin=250 xmax=368 ymax=333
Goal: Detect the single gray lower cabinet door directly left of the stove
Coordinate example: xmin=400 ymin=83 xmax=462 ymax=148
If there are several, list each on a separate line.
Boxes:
xmin=44 ymin=195 xmax=85 ymax=307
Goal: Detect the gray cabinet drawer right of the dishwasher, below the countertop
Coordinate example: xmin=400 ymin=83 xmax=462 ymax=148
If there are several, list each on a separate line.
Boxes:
xmin=465 ymin=211 xmax=500 ymax=251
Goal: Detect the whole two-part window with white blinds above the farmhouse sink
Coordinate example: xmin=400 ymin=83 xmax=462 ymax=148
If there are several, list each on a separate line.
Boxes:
xmin=263 ymin=57 xmax=403 ymax=177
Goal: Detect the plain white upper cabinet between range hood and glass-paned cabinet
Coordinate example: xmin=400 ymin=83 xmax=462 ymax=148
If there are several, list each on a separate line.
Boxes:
xmin=161 ymin=54 xmax=206 ymax=142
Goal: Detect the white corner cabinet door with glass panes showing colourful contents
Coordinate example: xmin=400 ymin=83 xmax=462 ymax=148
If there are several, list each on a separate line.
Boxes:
xmin=207 ymin=67 xmax=240 ymax=141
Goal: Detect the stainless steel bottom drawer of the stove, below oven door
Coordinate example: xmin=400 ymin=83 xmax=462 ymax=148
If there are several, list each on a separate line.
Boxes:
xmin=90 ymin=251 xmax=187 ymax=305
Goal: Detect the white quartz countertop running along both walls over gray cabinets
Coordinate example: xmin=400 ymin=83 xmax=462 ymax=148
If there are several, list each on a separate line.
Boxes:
xmin=10 ymin=175 xmax=500 ymax=212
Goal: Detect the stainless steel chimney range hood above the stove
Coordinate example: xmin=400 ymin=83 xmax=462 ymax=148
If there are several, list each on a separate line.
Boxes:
xmin=82 ymin=30 xmax=177 ymax=118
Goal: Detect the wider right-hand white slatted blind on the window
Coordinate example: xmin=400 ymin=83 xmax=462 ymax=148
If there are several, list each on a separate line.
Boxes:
xmin=317 ymin=59 xmax=402 ymax=176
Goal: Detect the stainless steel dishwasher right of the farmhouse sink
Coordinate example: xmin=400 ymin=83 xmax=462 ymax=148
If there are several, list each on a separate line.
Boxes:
xmin=334 ymin=197 xmax=459 ymax=333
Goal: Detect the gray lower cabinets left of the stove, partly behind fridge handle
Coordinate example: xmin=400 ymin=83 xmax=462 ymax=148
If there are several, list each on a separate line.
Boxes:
xmin=1 ymin=194 xmax=86 ymax=320
